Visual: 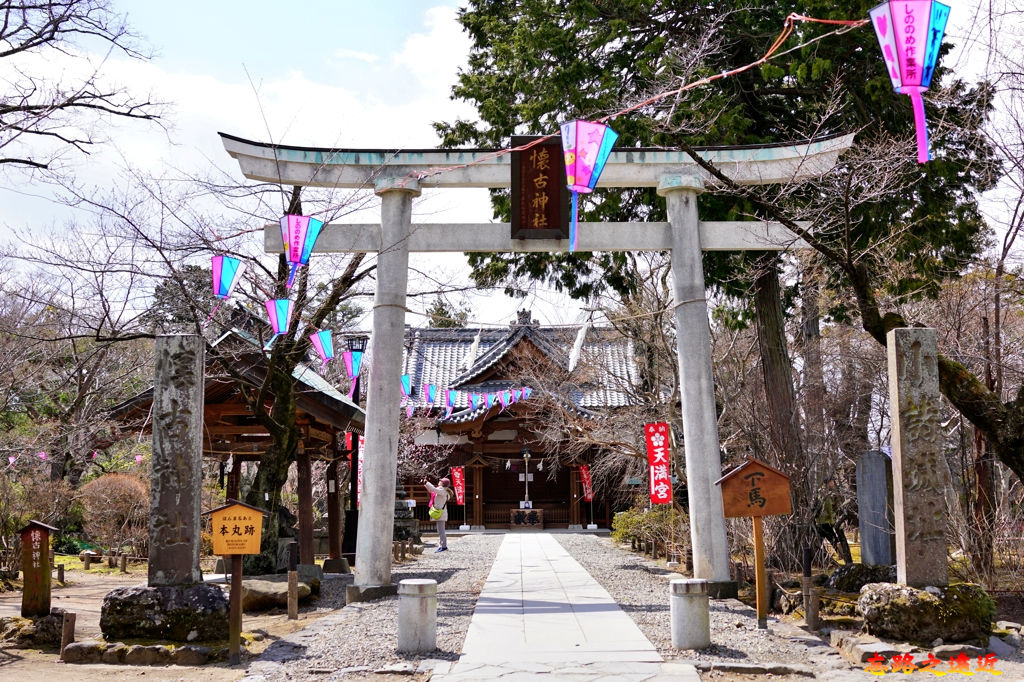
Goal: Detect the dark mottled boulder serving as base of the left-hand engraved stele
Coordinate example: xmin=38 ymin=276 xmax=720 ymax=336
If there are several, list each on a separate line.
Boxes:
xmin=99 ymin=584 xmax=228 ymax=642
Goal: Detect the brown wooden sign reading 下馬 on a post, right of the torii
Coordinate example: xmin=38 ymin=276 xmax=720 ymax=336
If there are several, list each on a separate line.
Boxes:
xmin=715 ymin=457 xmax=793 ymax=630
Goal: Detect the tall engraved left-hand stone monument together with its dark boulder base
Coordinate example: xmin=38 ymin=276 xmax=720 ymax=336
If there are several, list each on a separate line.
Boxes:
xmin=99 ymin=335 xmax=228 ymax=641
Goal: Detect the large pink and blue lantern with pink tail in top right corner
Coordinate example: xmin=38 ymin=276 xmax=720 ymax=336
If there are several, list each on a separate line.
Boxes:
xmin=868 ymin=0 xmax=949 ymax=164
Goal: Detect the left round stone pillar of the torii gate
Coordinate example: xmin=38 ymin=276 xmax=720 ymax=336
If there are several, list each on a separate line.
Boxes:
xmin=353 ymin=178 xmax=420 ymax=596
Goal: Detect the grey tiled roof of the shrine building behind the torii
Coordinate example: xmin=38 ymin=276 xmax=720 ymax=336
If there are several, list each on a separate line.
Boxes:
xmin=385 ymin=325 xmax=637 ymax=422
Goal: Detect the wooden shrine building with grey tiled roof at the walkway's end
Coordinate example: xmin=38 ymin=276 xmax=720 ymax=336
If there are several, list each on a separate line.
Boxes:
xmin=380 ymin=311 xmax=638 ymax=529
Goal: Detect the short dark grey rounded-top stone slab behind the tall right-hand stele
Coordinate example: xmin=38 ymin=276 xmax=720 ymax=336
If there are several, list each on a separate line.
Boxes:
xmin=857 ymin=450 xmax=896 ymax=566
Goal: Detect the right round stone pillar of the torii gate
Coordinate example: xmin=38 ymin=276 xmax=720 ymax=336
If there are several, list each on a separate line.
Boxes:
xmin=657 ymin=175 xmax=736 ymax=597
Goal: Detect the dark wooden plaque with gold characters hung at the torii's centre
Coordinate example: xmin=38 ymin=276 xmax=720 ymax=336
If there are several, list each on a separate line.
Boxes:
xmin=512 ymin=135 xmax=569 ymax=240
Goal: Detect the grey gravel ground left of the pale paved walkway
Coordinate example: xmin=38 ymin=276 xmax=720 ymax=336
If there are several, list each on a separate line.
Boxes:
xmin=246 ymin=535 xmax=503 ymax=682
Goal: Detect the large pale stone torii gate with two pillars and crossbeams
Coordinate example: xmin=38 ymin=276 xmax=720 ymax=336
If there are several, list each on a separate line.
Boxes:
xmin=221 ymin=133 xmax=853 ymax=596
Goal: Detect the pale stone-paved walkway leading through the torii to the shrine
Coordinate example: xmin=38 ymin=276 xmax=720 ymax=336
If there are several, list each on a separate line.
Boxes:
xmin=431 ymin=532 xmax=700 ymax=682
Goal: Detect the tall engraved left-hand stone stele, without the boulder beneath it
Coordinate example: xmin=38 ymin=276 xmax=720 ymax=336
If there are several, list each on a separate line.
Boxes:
xmin=150 ymin=335 xmax=205 ymax=587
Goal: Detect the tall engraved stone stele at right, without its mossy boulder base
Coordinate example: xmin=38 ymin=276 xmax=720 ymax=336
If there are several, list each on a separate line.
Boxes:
xmin=887 ymin=329 xmax=949 ymax=588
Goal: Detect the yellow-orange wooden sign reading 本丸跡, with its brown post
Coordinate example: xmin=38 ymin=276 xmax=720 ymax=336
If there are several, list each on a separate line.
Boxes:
xmin=204 ymin=500 xmax=267 ymax=666
